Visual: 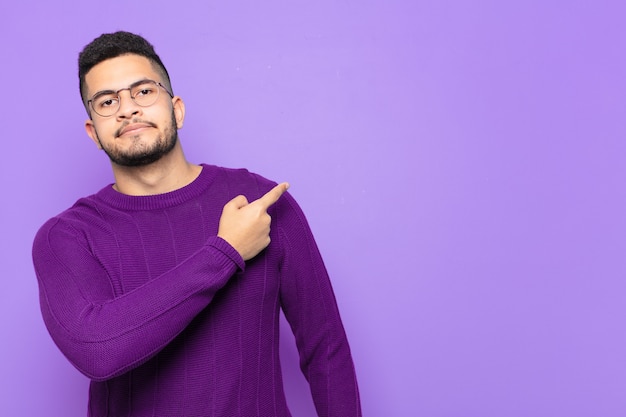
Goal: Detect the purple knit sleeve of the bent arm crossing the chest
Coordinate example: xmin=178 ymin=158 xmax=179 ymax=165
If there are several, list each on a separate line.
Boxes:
xmin=33 ymin=219 xmax=244 ymax=381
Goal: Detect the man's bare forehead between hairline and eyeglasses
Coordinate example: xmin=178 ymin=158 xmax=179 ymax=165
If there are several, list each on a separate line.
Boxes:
xmin=85 ymin=55 xmax=162 ymax=95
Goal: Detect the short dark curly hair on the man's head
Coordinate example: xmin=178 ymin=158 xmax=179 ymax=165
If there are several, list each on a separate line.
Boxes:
xmin=78 ymin=31 xmax=172 ymax=108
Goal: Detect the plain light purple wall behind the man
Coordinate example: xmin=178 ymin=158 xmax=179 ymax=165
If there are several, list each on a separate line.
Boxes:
xmin=0 ymin=0 xmax=626 ymax=417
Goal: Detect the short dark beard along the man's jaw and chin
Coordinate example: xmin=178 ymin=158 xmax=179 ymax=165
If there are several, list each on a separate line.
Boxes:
xmin=96 ymin=112 xmax=178 ymax=167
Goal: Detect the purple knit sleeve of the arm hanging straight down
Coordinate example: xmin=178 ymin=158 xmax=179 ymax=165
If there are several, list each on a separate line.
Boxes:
xmin=275 ymin=193 xmax=361 ymax=417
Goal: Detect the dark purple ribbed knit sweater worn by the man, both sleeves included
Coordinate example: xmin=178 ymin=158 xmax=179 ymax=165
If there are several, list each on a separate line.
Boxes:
xmin=33 ymin=165 xmax=361 ymax=417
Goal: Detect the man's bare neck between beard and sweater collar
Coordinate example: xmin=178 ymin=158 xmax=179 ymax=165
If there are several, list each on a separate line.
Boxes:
xmin=112 ymin=146 xmax=202 ymax=196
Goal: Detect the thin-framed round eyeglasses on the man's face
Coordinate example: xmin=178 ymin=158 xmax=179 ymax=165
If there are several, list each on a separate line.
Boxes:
xmin=87 ymin=80 xmax=174 ymax=117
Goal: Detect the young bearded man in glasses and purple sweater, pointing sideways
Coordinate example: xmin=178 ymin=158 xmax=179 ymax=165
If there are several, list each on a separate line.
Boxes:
xmin=33 ymin=32 xmax=361 ymax=417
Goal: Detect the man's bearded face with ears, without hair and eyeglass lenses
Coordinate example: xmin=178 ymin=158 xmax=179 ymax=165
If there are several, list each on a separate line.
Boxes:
xmin=85 ymin=55 xmax=184 ymax=166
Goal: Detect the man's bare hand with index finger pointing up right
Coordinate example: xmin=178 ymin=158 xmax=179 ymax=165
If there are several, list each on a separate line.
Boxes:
xmin=217 ymin=182 xmax=289 ymax=261
